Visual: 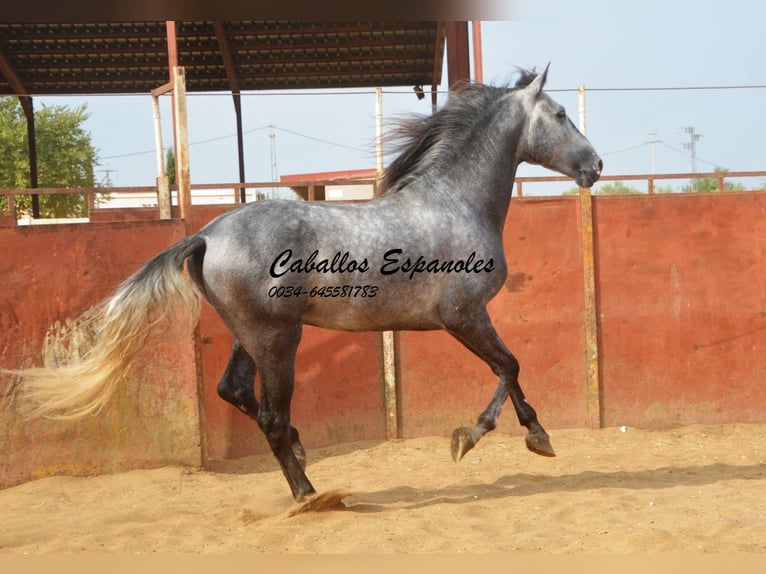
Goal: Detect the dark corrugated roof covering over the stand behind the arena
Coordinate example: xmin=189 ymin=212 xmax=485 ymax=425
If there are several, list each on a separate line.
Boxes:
xmin=0 ymin=21 xmax=444 ymax=96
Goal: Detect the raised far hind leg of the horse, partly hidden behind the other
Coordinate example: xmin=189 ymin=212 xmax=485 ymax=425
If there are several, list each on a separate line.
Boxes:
xmin=218 ymin=339 xmax=306 ymax=469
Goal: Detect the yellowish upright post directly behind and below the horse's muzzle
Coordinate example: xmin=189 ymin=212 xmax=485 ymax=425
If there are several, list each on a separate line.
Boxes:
xmin=579 ymin=86 xmax=602 ymax=428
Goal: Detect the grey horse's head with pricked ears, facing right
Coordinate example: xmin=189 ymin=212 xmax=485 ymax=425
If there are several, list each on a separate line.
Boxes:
xmin=518 ymin=66 xmax=604 ymax=187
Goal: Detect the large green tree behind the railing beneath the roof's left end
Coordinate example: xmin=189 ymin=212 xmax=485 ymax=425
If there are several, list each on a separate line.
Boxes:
xmin=0 ymin=97 xmax=98 ymax=217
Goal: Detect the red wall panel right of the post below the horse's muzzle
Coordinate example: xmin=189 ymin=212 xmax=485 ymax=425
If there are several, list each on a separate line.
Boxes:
xmin=594 ymin=193 xmax=766 ymax=427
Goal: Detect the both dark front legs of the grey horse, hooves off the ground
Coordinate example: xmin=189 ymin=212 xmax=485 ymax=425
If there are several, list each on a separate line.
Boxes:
xmin=448 ymin=311 xmax=555 ymax=462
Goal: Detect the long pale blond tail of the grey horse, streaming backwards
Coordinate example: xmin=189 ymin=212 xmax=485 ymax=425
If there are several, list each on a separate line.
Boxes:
xmin=15 ymin=235 xmax=205 ymax=418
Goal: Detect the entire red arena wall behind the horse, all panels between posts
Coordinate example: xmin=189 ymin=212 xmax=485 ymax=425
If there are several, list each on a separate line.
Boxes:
xmin=0 ymin=192 xmax=766 ymax=486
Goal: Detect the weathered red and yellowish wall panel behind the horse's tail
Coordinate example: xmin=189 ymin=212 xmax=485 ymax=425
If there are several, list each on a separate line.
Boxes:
xmin=0 ymin=221 xmax=200 ymax=486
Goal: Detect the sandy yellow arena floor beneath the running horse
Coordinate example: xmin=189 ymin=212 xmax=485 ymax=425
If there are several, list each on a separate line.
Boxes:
xmin=0 ymin=424 xmax=766 ymax=554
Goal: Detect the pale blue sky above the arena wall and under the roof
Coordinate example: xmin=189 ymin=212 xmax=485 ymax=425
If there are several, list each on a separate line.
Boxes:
xmin=36 ymin=0 xmax=766 ymax=195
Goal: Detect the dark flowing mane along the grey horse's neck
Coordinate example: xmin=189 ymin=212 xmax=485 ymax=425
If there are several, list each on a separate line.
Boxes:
xmin=378 ymin=69 xmax=537 ymax=195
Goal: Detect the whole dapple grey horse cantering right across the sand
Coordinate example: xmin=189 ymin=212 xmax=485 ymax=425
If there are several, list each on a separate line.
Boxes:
xmin=20 ymin=67 xmax=602 ymax=501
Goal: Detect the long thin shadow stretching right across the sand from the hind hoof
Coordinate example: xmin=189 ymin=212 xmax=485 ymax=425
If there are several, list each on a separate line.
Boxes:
xmin=341 ymin=463 xmax=766 ymax=513
